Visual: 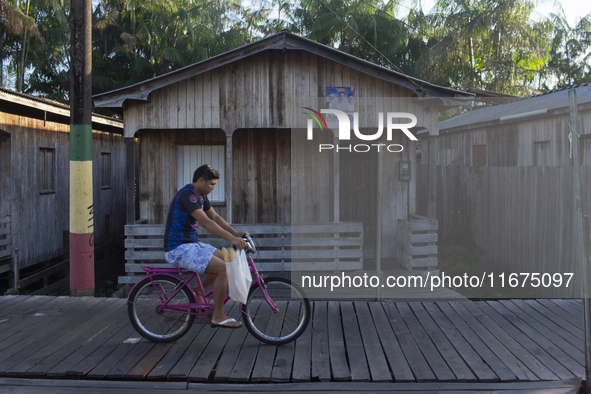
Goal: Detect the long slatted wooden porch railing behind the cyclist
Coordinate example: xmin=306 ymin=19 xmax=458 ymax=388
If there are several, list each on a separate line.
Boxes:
xmin=119 ymin=223 xmax=363 ymax=283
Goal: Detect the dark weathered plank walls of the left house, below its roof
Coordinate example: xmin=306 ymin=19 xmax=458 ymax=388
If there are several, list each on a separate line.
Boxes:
xmin=0 ymin=111 xmax=125 ymax=268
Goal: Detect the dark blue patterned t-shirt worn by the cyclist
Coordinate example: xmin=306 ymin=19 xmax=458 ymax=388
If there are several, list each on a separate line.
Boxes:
xmin=164 ymin=183 xmax=211 ymax=252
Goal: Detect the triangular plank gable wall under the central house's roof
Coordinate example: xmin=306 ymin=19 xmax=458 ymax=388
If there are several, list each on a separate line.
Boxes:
xmin=124 ymin=50 xmax=438 ymax=138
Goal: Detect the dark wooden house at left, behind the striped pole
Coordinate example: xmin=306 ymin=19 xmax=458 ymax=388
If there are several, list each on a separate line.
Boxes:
xmin=0 ymin=89 xmax=125 ymax=280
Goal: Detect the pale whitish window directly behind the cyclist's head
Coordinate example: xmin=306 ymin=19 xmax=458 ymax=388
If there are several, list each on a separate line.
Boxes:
xmin=177 ymin=145 xmax=226 ymax=202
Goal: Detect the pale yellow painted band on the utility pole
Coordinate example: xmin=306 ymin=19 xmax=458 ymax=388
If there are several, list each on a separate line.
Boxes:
xmin=70 ymin=161 xmax=94 ymax=234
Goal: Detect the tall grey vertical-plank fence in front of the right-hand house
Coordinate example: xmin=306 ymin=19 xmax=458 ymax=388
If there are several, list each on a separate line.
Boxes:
xmin=437 ymin=166 xmax=591 ymax=297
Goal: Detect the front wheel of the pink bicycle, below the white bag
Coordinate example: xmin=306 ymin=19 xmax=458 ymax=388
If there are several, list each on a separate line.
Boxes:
xmin=242 ymin=277 xmax=311 ymax=345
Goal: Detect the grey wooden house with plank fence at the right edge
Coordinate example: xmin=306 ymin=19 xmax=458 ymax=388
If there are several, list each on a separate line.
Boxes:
xmin=417 ymin=83 xmax=591 ymax=294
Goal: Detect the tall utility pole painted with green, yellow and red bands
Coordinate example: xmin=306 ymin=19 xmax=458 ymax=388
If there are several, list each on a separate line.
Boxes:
xmin=70 ymin=0 xmax=94 ymax=297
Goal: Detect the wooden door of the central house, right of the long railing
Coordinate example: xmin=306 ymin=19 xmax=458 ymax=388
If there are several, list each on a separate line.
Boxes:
xmin=339 ymin=151 xmax=377 ymax=268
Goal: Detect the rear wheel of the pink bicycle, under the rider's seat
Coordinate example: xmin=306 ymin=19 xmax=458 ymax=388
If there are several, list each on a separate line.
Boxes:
xmin=127 ymin=275 xmax=195 ymax=342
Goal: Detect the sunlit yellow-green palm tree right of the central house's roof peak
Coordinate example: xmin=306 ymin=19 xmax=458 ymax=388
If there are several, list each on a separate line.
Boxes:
xmin=418 ymin=0 xmax=551 ymax=94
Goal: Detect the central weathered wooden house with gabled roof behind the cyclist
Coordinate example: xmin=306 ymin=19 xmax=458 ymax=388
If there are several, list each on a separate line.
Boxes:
xmin=94 ymin=31 xmax=470 ymax=276
